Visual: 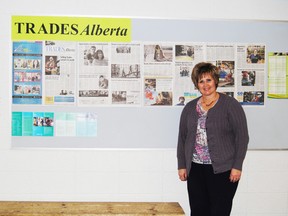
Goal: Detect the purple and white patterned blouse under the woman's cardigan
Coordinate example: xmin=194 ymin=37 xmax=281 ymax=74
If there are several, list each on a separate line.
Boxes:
xmin=192 ymin=100 xmax=212 ymax=164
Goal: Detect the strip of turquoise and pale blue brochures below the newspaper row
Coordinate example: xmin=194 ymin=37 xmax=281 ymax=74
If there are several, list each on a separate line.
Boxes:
xmin=12 ymin=112 xmax=97 ymax=137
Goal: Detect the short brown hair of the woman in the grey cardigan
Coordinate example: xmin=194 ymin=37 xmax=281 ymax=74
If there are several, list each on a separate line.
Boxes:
xmin=191 ymin=62 xmax=220 ymax=89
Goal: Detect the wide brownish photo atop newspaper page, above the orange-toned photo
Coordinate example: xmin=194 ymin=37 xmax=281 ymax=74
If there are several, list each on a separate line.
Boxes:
xmin=144 ymin=44 xmax=173 ymax=63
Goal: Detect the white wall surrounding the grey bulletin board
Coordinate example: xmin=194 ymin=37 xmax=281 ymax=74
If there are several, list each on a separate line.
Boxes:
xmin=0 ymin=0 xmax=288 ymax=216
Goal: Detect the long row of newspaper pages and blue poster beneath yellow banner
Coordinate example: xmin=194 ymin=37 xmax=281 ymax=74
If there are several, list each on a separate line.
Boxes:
xmin=12 ymin=41 xmax=265 ymax=107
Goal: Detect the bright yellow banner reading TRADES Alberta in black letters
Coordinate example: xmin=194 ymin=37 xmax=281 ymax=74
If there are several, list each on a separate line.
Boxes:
xmin=12 ymin=16 xmax=132 ymax=42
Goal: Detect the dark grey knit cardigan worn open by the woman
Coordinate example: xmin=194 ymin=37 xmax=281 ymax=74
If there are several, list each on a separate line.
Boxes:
xmin=177 ymin=93 xmax=249 ymax=175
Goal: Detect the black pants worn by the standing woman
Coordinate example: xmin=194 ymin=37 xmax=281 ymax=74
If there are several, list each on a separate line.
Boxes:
xmin=187 ymin=162 xmax=238 ymax=216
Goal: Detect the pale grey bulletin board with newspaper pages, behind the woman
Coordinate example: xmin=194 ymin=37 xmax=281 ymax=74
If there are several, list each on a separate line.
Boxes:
xmin=12 ymin=16 xmax=288 ymax=149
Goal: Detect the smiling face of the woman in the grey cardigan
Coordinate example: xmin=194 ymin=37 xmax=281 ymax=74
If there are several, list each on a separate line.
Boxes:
xmin=198 ymin=73 xmax=216 ymax=96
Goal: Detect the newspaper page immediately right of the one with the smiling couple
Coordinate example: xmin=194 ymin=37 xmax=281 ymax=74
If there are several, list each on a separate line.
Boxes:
xmin=110 ymin=43 xmax=143 ymax=106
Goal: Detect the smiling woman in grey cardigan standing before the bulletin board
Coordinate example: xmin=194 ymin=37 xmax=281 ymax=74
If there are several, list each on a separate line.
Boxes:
xmin=177 ymin=62 xmax=249 ymax=216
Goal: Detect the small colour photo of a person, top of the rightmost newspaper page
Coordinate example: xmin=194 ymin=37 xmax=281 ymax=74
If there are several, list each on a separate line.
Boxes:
xmin=246 ymin=46 xmax=265 ymax=64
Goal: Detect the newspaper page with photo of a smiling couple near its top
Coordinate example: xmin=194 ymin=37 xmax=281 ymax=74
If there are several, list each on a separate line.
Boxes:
xmin=75 ymin=43 xmax=111 ymax=106
